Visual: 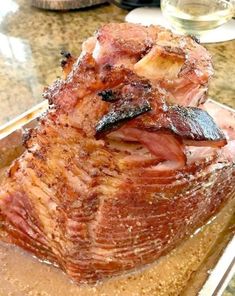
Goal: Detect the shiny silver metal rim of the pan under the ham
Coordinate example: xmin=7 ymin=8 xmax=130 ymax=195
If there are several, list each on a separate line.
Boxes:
xmin=0 ymin=100 xmax=235 ymax=296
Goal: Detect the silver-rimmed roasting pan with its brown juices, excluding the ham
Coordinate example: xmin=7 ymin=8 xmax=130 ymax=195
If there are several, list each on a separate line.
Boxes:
xmin=0 ymin=101 xmax=235 ymax=296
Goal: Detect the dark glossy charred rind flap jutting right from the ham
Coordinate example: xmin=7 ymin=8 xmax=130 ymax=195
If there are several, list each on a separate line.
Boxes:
xmin=135 ymin=106 xmax=227 ymax=147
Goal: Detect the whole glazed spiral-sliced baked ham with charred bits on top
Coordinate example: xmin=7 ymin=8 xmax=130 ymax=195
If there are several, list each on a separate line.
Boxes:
xmin=0 ymin=24 xmax=235 ymax=283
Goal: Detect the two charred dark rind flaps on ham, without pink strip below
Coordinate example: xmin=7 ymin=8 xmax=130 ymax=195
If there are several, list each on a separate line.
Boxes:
xmin=96 ymin=69 xmax=227 ymax=147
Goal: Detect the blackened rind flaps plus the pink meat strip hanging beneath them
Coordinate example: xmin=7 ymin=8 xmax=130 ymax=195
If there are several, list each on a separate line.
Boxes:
xmin=96 ymin=75 xmax=227 ymax=168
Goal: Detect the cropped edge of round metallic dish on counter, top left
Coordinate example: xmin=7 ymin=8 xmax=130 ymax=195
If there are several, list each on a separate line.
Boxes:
xmin=30 ymin=0 xmax=107 ymax=10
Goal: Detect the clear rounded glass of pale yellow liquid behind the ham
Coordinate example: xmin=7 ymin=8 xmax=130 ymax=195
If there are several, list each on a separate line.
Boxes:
xmin=161 ymin=0 xmax=235 ymax=35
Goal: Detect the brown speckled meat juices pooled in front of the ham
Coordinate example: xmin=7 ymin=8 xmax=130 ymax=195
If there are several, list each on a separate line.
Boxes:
xmin=0 ymin=200 xmax=235 ymax=296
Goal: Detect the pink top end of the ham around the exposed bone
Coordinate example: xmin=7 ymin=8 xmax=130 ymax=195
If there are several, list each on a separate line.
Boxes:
xmin=86 ymin=24 xmax=213 ymax=106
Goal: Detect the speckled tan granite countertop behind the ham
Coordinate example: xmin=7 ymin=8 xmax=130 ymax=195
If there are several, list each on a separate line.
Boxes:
xmin=0 ymin=0 xmax=235 ymax=296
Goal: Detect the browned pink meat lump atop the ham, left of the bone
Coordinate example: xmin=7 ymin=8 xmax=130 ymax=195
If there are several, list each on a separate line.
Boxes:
xmin=93 ymin=23 xmax=162 ymax=67
